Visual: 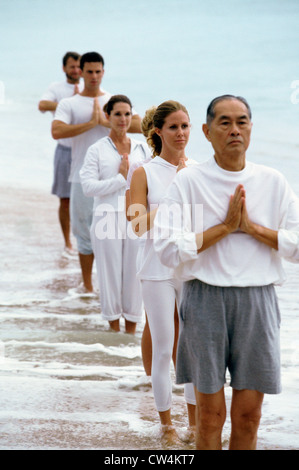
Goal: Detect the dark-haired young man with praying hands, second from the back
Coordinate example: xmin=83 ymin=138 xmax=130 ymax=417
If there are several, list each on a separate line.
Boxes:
xmin=52 ymin=52 xmax=141 ymax=294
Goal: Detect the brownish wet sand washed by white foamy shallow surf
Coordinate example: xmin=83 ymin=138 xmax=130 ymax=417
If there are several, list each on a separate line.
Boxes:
xmin=0 ymin=188 xmax=298 ymax=450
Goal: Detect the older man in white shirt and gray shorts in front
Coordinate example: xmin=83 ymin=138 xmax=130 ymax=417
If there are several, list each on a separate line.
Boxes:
xmin=155 ymin=95 xmax=299 ymax=450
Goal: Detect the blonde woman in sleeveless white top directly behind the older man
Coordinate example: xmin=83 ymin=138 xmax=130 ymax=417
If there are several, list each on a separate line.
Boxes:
xmin=130 ymin=101 xmax=195 ymax=446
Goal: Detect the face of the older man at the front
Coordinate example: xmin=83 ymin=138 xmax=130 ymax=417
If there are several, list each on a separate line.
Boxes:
xmin=203 ymin=99 xmax=252 ymax=158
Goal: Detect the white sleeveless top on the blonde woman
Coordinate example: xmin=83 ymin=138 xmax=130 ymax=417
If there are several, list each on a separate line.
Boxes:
xmin=137 ymin=156 xmax=196 ymax=281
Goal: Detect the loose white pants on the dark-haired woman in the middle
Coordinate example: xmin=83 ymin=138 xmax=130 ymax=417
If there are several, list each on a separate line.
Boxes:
xmin=91 ymin=212 xmax=143 ymax=323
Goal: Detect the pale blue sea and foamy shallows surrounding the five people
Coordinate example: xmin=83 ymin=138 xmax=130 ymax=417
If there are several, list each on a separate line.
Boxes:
xmin=0 ymin=0 xmax=299 ymax=449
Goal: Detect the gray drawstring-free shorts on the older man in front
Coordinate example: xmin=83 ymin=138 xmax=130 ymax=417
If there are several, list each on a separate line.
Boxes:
xmin=177 ymin=279 xmax=281 ymax=394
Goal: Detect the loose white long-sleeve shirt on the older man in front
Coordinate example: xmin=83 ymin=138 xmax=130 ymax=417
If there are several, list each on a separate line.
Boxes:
xmin=154 ymin=158 xmax=299 ymax=287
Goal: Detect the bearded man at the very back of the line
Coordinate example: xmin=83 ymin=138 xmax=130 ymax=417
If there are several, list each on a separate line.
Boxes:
xmin=38 ymin=52 xmax=80 ymax=258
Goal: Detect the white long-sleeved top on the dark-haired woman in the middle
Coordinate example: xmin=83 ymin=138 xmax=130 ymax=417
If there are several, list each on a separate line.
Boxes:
xmin=80 ymin=136 xmax=150 ymax=212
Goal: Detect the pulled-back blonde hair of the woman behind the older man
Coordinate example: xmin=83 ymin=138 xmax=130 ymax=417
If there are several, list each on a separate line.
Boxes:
xmin=141 ymin=100 xmax=189 ymax=157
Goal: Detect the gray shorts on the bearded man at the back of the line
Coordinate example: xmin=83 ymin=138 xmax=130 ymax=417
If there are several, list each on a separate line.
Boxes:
xmin=52 ymin=144 xmax=72 ymax=199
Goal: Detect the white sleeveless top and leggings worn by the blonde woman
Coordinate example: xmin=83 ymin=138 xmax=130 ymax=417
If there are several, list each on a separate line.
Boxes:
xmin=138 ymin=156 xmax=196 ymax=412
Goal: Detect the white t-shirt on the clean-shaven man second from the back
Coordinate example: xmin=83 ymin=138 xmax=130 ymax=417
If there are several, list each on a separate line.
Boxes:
xmin=54 ymin=92 xmax=111 ymax=183
